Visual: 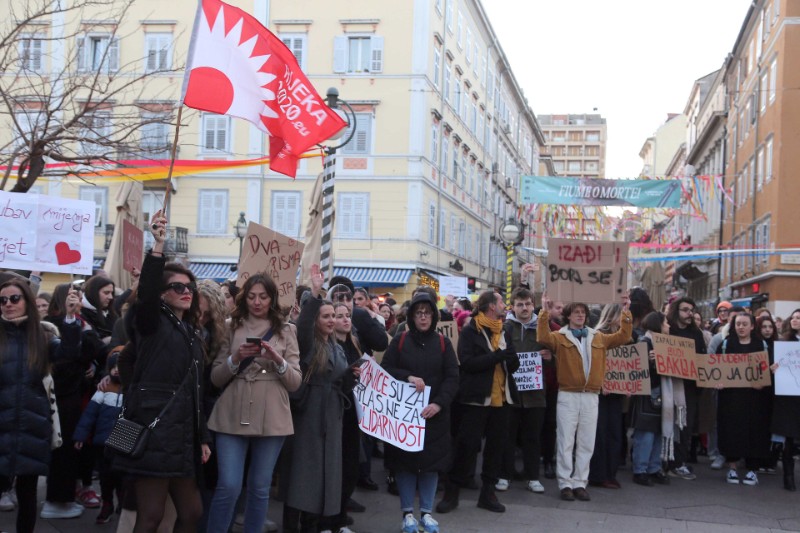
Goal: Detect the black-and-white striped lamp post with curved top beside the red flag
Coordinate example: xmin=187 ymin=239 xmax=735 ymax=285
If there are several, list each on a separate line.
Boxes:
xmin=319 ymin=87 xmax=356 ymax=281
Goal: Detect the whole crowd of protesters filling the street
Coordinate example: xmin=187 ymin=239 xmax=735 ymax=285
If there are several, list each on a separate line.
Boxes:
xmin=0 ymin=216 xmax=800 ymax=533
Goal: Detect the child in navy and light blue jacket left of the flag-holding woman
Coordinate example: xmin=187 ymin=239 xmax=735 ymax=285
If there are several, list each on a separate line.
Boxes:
xmin=73 ymin=346 xmax=124 ymax=524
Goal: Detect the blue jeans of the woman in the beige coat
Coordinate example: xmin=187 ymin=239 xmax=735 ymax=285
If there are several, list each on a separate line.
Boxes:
xmin=208 ymin=433 xmax=285 ymax=533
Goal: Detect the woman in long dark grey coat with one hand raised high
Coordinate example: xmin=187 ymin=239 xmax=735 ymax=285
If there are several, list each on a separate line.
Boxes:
xmin=283 ymin=265 xmax=359 ymax=533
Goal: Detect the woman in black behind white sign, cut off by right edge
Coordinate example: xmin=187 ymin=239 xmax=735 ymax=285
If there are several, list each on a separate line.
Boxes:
xmin=772 ymin=309 xmax=800 ymax=491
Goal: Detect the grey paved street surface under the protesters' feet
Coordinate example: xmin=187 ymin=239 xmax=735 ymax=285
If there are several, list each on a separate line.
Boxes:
xmin=0 ymin=458 xmax=800 ymax=533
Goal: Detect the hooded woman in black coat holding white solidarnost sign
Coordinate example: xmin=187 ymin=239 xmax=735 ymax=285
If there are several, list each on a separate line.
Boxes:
xmin=382 ymin=292 xmax=458 ymax=531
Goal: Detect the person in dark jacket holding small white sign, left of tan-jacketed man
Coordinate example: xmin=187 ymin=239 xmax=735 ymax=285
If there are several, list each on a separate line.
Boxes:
xmin=495 ymin=287 xmax=552 ymax=493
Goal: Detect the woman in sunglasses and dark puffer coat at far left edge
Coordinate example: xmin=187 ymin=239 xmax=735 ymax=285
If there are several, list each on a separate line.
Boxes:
xmin=0 ymin=279 xmax=81 ymax=533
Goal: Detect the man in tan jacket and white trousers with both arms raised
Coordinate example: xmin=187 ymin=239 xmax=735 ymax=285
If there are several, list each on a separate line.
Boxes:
xmin=536 ymin=295 xmax=632 ymax=501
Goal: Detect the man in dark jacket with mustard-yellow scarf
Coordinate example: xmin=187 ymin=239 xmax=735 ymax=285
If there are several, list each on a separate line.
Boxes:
xmin=436 ymin=290 xmax=519 ymax=513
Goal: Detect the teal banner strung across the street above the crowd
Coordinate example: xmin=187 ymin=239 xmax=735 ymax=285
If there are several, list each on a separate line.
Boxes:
xmin=522 ymin=176 xmax=681 ymax=208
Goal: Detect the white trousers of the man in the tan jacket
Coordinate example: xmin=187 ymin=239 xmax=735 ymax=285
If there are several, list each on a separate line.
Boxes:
xmin=556 ymin=391 xmax=599 ymax=489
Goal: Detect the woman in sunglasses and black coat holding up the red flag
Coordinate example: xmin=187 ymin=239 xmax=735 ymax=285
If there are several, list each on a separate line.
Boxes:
xmin=114 ymin=210 xmax=211 ymax=533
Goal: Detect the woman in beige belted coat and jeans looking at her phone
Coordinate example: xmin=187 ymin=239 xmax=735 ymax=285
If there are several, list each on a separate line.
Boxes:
xmin=208 ymin=274 xmax=302 ymax=533
